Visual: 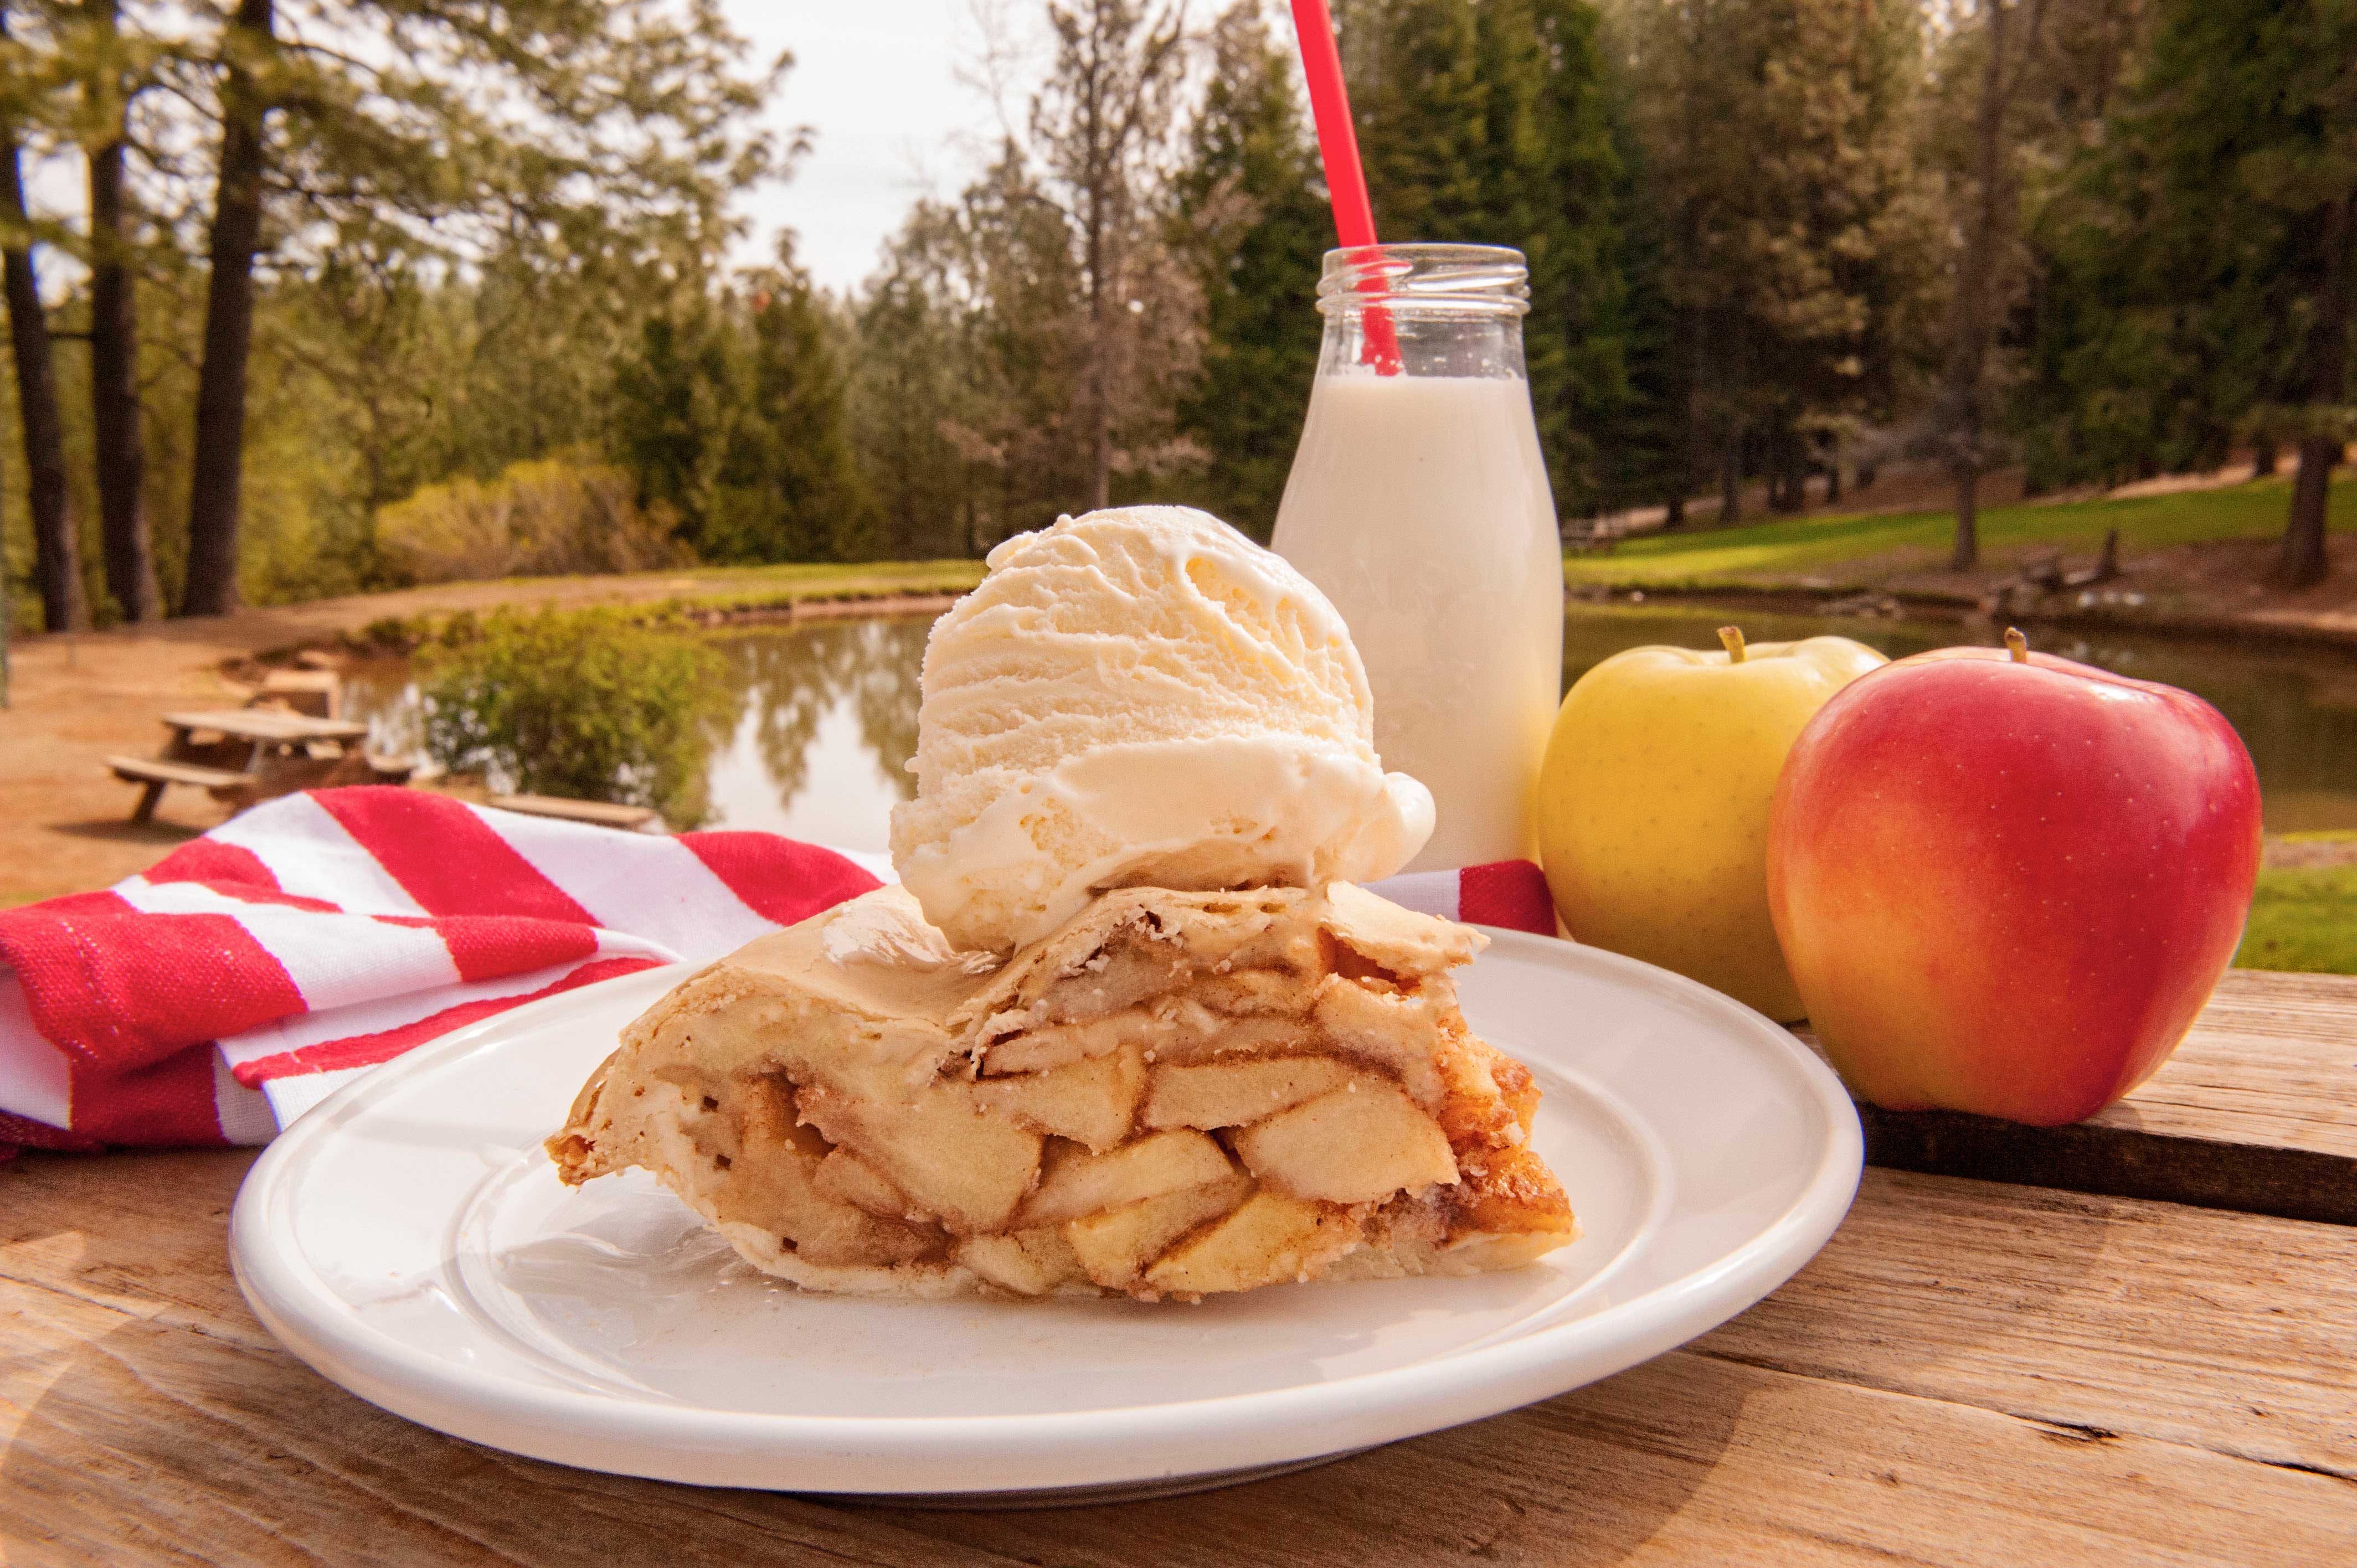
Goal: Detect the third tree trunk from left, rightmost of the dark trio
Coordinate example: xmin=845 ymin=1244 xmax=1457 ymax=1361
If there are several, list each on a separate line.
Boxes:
xmin=179 ymin=0 xmax=276 ymax=616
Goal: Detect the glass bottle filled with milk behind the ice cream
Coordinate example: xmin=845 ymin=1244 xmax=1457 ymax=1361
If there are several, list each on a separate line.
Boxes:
xmin=1273 ymin=245 xmax=1563 ymax=870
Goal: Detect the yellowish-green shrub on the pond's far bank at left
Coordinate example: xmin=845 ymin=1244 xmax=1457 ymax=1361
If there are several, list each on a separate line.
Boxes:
xmin=377 ymin=457 xmax=691 ymax=582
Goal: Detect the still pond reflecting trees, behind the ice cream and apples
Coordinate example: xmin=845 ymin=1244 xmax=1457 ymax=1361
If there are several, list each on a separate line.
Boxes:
xmin=349 ymin=604 xmax=2357 ymax=851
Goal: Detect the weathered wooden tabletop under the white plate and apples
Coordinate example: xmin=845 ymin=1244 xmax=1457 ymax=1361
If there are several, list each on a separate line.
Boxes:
xmin=0 ymin=972 xmax=2357 ymax=1568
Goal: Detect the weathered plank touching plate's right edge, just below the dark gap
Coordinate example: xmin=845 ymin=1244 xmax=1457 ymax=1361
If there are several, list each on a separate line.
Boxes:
xmin=1695 ymin=1172 xmax=2357 ymax=1488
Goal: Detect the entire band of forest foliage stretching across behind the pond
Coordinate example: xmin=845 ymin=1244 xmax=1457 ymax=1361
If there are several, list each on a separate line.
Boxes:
xmin=0 ymin=0 xmax=2357 ymax=627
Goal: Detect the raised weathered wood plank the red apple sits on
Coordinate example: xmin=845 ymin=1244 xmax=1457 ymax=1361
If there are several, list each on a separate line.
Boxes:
xmin=1803 ymin=969 xmax=2357 ymax=1224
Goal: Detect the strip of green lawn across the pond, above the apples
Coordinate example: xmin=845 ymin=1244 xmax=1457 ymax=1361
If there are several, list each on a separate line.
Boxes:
xmin=1563 ymin=479 xmax=2357 ymax=587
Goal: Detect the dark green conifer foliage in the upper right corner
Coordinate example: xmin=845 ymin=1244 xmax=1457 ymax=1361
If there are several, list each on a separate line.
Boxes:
xmin=2018 ymin=0 xmax=2357 ymax=483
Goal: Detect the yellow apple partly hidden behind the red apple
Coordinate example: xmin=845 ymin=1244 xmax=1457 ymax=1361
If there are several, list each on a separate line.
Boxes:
xmin=1539 ymin=627 xmax=1888 ymax=1023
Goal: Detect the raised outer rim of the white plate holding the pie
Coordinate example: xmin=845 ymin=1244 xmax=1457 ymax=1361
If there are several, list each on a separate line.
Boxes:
xmin=229 ymin=927 xmax=1864 ymax=1497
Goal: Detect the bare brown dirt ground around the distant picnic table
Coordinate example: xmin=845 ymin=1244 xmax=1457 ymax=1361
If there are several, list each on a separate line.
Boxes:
xmin=0 ymin=577 xmax=948 ymax=908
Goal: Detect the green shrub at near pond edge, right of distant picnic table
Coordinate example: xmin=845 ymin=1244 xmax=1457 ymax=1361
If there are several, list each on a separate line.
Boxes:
xmin=422 ymin=611 xmax=728 ymax=828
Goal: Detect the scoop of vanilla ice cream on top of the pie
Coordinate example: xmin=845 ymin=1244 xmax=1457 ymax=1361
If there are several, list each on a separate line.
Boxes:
xmin=891 ymin=507 xmax=1433 ymax=952
